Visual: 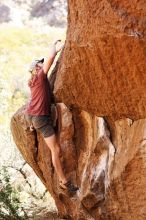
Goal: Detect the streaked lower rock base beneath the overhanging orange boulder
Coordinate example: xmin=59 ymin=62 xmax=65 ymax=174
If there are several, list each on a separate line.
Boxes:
xmin=11 ymin=104 xmax=146 ymax=220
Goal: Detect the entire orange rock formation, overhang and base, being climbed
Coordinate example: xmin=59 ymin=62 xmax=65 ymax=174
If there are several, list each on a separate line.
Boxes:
xmin=11 ymin=0 xmax=146 ymax=220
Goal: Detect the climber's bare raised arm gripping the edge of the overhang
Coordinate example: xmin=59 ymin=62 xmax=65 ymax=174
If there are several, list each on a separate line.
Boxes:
xmin=43 ymin=40 xmax=64 ymax=74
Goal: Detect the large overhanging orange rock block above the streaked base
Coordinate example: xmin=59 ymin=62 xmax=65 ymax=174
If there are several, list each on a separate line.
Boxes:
xmin=54 ymin=0 xmax=146 ymax=119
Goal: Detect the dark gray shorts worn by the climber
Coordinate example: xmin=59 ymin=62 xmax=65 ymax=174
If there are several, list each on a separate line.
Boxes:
xmin=25 ymin=115 xmax=55 ymax=138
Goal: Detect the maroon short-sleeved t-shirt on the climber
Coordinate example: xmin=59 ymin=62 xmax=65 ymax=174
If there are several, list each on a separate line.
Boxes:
xmin=25 ymin=69 xmax=51 ymax=115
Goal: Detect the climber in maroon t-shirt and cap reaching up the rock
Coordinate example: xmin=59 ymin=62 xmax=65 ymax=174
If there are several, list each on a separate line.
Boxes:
xmin=25 ymin=40 xmax=78 ymax=193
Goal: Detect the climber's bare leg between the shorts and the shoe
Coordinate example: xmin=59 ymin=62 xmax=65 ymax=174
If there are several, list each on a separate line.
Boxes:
xmin=44 ymin=134 xmax=67 ymax=183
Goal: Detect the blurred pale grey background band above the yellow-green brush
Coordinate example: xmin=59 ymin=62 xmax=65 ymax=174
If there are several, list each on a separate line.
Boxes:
xmin=0 ymin=0 xmax=67 ymax=27
